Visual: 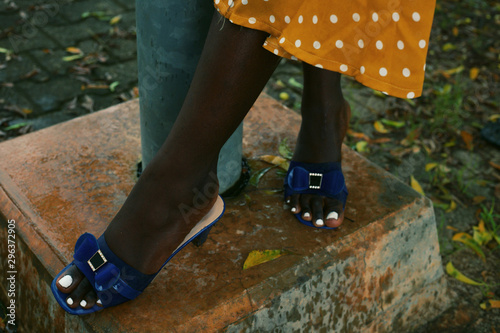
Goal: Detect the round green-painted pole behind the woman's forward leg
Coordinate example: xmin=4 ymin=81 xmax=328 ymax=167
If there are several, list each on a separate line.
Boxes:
xmin=136 ymin=0 xmax=243 ymax=193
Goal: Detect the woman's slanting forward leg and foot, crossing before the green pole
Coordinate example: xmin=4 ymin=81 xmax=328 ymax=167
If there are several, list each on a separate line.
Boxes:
xmin=58 ymin=13 xmax=279 ymax=308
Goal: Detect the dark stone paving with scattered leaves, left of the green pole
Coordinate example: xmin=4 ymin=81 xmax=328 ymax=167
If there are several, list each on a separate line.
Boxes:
xmin=0 ymin=0 xmax=138 ymax=136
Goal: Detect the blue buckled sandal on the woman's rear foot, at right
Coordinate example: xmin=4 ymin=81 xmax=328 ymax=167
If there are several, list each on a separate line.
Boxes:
xmin=285 ymin=161 xmax=348 ymax=229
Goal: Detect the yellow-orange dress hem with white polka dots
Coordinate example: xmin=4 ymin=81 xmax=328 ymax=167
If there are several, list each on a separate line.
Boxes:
xmin=214 ymin=0 xmax=435 ymax=98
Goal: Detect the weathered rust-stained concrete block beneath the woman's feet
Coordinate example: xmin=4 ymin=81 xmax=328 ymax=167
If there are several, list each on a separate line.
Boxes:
xmin=0 ymin=95 xmax=448 ymax=332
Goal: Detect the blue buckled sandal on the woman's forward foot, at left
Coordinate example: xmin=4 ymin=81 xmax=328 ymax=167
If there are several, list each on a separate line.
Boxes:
xmin=51 ymin=196 xmax=224 ymax=315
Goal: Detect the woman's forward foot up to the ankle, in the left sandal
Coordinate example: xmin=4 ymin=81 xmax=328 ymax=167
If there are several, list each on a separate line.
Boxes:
xmin=56 ymin=158 xmax=218 ymax=309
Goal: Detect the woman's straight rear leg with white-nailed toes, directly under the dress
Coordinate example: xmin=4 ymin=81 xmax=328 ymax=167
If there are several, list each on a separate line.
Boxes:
xmin=285 ymin=65 xmax=351 ymax=228
